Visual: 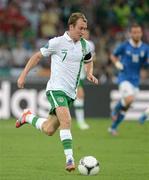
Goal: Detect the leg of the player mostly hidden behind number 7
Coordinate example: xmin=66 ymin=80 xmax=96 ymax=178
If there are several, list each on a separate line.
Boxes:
xmin=74 ymin=81 xmax=89 ymax=130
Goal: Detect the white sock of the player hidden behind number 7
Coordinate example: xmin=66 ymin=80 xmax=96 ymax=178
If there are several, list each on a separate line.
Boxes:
xmin=74 ymin=99 xmax=85 ymax=123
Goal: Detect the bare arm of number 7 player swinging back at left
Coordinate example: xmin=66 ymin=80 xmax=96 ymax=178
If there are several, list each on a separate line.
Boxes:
xmin=17 ymin=51 xmax=43 ymax=88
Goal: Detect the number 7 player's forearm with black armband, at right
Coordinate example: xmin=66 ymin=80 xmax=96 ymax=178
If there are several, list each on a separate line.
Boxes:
xmin=84 ymin=53 xmax=98 ymax=84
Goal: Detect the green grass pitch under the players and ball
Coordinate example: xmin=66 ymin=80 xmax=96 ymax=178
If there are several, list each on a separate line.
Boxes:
xmin=0 ymin=119 xmax=149 ymax=180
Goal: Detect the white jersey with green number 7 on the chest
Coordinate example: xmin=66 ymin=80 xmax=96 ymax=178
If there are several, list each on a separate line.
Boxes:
xmin=40 ymin=32 xmax=92 ymax=99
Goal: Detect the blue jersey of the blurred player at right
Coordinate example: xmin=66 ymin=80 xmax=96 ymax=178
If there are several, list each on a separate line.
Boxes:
xmin=113 ymin=41 xmax=149 ymax=87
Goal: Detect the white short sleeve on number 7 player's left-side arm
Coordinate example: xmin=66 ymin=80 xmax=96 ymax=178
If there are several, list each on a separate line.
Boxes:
xmin=40 ymin=38 xmax=58 ymax=57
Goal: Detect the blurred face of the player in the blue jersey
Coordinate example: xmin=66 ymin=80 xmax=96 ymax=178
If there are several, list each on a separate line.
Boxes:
xmin=130 ymin=27 xmax=142 ymax=42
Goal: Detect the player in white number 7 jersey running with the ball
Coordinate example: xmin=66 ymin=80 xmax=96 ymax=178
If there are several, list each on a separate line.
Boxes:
xmin=16 ymin=12 xmax=98 ymax=171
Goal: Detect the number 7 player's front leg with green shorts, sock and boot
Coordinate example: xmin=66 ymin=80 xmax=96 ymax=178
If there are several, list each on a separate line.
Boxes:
xmin=48 ymin=91 xmax=75 ymax=171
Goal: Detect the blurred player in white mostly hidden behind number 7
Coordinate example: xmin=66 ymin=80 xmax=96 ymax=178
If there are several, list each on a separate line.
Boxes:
xmin=73 ymin=30 xmax=95 ymax=130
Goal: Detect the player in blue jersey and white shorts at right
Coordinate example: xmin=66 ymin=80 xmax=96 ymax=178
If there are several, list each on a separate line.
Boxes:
xmin=108 ymin=24 xmax=149 ymax=135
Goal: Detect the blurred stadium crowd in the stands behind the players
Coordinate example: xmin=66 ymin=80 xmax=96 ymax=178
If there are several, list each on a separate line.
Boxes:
xmin=0 ymin=0 xmax=149 ymax=83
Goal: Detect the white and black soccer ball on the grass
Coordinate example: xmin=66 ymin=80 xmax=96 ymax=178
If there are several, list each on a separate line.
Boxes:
xmin=78 ymin=156 xmax=100 ymax=176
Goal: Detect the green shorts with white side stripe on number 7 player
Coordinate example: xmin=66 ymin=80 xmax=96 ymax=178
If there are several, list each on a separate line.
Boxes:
xmin=46 ymin=91 xmax=74 ymax=114
